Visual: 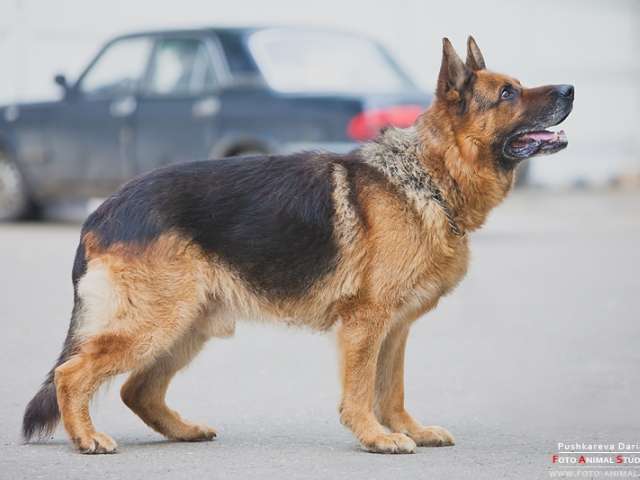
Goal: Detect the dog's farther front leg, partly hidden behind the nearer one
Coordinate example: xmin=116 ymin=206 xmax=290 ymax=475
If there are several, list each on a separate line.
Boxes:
xmin=376 ymin=323 xmax=455 ymax=447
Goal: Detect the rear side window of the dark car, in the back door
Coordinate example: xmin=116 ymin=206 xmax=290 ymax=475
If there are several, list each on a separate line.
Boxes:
xmin=145 ymin=38 xmax=216 ymax=96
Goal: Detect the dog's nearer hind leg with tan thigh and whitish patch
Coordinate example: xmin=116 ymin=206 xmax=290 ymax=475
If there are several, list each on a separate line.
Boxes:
xmin=54 ymin=237 xmax=212 ymax=453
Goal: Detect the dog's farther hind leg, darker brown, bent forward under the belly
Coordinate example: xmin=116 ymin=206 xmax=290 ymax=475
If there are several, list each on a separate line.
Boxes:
xmin=120 ymin=333 xmax=216 ymax=442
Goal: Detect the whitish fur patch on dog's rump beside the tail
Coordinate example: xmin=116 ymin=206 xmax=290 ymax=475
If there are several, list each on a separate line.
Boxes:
xmin=76 ymin=263 xmax=120 ymax=337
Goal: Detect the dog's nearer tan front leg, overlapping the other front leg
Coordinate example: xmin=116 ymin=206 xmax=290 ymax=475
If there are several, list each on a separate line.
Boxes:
xmin=338 ymin=307 xmax=416 ymax=453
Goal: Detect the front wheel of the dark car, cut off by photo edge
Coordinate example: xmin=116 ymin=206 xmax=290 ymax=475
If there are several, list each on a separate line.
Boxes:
xmin=0 ymin=151 xmax=30 ymax=222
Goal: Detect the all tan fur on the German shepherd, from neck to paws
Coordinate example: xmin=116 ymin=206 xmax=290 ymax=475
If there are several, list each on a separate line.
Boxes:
xmin=55 ymin=37 xmax=556 ymax=453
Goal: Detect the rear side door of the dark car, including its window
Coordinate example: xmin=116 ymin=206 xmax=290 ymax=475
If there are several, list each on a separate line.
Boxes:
xmin=136 ymin=35 xmax=220 ymax=172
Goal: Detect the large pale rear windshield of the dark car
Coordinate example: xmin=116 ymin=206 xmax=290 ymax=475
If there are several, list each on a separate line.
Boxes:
xmin=249 ymin=29 xmax=415 ymax=94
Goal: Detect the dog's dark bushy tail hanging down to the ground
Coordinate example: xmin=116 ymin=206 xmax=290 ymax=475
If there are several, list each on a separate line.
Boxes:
xmin=22 ymin=244 xmax=86 ymax=442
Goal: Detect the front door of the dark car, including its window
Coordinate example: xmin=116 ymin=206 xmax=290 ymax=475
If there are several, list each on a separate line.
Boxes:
xmin=46 ymin=36 xmax=153 ymax=198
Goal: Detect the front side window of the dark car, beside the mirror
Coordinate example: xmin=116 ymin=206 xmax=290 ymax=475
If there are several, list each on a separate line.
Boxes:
xmin=80 ymin=37 xmax=153 ymax=98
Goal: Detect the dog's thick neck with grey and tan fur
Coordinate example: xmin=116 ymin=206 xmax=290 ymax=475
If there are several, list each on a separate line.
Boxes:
xmin=362 ymin=109 xmax=512 ymax=234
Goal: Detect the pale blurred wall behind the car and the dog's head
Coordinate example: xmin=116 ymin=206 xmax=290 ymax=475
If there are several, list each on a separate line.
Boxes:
xmin=0 ymin=0 xmax=640 ymax=186
